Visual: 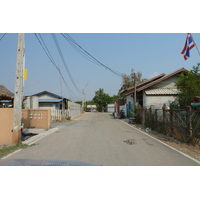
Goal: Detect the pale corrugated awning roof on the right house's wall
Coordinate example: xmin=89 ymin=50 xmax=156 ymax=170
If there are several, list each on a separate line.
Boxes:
xmin=145 ymin=88 xmax=178 ymax=95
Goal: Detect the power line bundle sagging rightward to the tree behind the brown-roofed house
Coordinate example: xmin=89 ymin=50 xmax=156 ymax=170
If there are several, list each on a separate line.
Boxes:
xmin=61 ymin=33 xmax=122 ymax=77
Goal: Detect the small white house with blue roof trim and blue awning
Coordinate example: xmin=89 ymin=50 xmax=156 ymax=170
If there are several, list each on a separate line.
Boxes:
xmin=25 ymin=91 xmax=68 ymax=110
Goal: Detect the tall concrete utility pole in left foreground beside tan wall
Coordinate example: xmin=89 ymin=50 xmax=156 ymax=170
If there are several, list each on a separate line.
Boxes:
xmin=13 ymin=33 xmax=25 ymax=140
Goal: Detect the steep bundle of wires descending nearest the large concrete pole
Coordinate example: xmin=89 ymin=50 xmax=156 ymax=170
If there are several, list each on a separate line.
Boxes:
xmin=35 ymin=33 xmax=77 ymax=99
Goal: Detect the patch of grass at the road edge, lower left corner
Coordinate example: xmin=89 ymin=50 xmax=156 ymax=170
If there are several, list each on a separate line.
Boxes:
xmin=0 ymin=144 xmax=35 ymax=158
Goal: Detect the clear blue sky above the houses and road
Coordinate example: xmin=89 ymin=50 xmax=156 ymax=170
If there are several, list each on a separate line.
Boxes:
xmin=0 ymin=33 xmax=200 ymax=101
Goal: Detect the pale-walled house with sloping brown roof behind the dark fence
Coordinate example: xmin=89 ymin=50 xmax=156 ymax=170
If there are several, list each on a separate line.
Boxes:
xmin=121 ymin=68 xmax=188 ymax=116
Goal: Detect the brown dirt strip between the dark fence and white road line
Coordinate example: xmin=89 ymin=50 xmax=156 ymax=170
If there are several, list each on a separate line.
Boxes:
xmin=132 ymin=124 xmax=200 ymax=161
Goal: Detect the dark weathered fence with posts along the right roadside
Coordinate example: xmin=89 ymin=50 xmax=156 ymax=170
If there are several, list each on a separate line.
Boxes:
xmin=136 ymin=107 xmax=200 ymax=144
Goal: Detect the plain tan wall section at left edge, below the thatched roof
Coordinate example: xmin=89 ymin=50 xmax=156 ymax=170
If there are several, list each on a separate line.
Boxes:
xmin=0 ymin=108 xmax=21 ymax=145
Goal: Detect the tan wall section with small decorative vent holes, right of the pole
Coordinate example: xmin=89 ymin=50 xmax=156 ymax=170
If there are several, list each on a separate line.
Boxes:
xmin=22 ymin=109 xmax=51 ymax=129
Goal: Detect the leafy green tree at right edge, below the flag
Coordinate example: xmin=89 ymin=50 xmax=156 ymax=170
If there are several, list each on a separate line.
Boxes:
xmin=176 ymin=63 xmax=200 ymax=107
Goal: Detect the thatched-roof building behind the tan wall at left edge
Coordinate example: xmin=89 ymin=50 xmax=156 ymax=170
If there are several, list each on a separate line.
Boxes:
xmin=0 ymin=85 xmax=14 ymax=108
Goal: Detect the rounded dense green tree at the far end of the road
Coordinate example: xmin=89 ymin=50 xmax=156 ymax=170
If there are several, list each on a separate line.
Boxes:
xmin=93 ymin=88 xmax=113 ymax=112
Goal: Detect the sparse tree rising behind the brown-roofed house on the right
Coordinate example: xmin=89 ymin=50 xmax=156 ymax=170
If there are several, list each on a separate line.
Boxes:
xmin=118 ymin=69 xmax=147 ymax=97
